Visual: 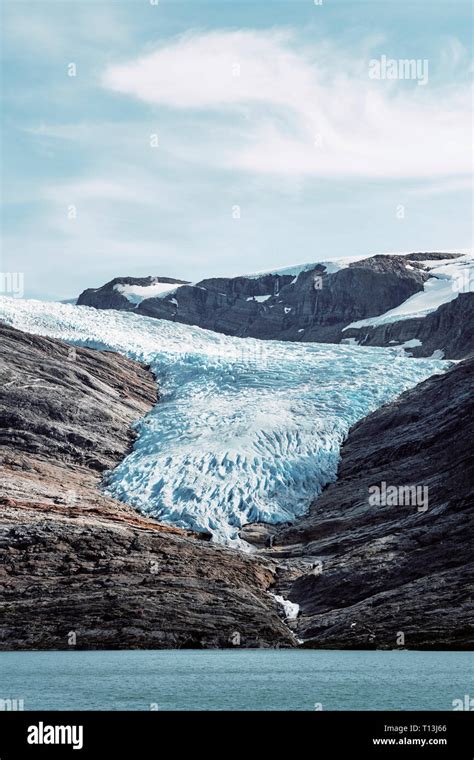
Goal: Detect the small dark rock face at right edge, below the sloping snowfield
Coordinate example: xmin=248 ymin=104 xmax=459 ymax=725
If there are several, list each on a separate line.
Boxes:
xmin=344 ymin=293 xmax=474 ymax=359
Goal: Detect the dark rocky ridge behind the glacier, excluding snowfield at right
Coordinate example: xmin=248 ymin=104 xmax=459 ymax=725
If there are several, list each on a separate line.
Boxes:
xmin=77 ymin=253 xmax=458 ymax=342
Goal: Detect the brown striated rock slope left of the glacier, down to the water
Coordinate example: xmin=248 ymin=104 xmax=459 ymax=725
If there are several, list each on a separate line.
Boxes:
xmin=0 ymin=325 xmax=295 ymax=650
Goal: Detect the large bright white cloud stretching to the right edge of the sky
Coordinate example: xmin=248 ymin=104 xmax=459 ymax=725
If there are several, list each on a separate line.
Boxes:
xmin=102 ymin=31 xmax=471 ymax=178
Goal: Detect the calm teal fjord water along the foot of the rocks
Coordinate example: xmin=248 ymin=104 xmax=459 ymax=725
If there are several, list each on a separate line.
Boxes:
xmin=0 ymin=649 xmax=473 ymax=710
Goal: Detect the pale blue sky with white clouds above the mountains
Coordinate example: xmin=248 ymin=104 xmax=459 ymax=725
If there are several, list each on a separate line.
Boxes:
xmin=0 ymin=0 xmax=473 ymax=299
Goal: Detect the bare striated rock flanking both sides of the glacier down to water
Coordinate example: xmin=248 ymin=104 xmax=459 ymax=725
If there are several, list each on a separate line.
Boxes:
xmin=0 ymin=318 xmax=474 ymax=650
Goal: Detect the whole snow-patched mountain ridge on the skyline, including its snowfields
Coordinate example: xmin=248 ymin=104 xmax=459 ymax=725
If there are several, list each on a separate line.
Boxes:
xmin=78 ymin=253 xmax=472 ymax=358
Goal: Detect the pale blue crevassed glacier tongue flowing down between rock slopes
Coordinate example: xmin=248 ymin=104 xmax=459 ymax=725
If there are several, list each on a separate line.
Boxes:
xmin=0 ymin=298 xmax=448 ymax=545
